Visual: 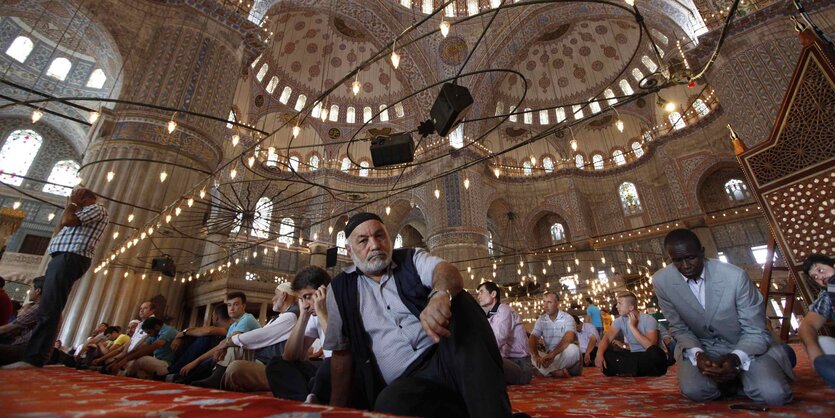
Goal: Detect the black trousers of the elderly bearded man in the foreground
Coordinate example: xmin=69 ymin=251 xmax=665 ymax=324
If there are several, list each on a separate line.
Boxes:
xmin=374 ymin=292 xmax=511 ymax=418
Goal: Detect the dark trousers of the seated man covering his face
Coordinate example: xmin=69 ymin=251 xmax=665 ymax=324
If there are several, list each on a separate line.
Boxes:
xmin=266 ymin=357 xmax=331 ymax=404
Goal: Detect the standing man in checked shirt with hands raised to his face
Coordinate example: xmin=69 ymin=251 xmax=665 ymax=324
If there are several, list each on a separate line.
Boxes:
xmin=6 ymin=188 xmax=108 ymax=368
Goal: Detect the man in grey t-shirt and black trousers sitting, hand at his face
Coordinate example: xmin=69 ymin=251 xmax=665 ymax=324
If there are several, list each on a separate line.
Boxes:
xmin=595 ymin=292 xmax=667 ymax=376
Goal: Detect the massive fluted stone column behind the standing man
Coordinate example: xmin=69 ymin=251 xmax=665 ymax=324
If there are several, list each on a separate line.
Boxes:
xmin=60 ymin=5 xmax=250 ymax=345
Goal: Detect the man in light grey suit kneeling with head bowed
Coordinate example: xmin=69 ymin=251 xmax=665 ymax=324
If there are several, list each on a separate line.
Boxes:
xmin=652 ymin=229 xmax=794 ymax=405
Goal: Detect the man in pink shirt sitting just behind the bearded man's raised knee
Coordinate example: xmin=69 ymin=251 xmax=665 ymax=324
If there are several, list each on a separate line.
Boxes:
xmin=476 ymin=282 xmax=533 ymax=385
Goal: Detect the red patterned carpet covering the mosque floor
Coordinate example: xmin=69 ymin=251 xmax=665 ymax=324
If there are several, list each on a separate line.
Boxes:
xmin=0 ymin=347 xmax=835 ymax=418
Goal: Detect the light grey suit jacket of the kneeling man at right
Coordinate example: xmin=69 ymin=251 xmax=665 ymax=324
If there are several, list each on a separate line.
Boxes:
xmin=652 ymin=259 xmax=794 ymax=378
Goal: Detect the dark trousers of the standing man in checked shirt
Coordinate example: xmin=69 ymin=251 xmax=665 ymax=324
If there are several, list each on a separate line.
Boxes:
xmin=24 ymin=253 xmax=90 ymax=367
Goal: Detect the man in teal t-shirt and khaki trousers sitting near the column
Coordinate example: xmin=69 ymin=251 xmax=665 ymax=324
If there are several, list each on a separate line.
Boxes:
xmin=108 ymin=317 xmax=177 ymax=379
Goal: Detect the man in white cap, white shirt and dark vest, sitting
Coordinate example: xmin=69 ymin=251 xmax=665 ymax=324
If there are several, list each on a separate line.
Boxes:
xmin=219 ymin=283 xmax=299 ymax=392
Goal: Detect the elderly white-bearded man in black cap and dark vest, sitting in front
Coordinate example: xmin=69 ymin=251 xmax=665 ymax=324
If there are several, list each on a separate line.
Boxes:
xmin=324 ymin=213 xmax=511 ymax=417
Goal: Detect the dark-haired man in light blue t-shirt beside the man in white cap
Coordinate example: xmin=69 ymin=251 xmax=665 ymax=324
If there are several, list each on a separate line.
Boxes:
xmin=180 ymin=292 xmax=261 ymax=388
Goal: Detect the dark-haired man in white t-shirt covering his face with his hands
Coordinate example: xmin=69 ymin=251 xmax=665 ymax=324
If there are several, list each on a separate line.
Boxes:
xmin=267 ymin=266 xmax=331 ymax=404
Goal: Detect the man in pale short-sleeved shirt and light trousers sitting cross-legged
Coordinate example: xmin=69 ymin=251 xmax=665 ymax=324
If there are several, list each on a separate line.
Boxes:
xmin=528 ymin=292 xmax=583 ymax=377
